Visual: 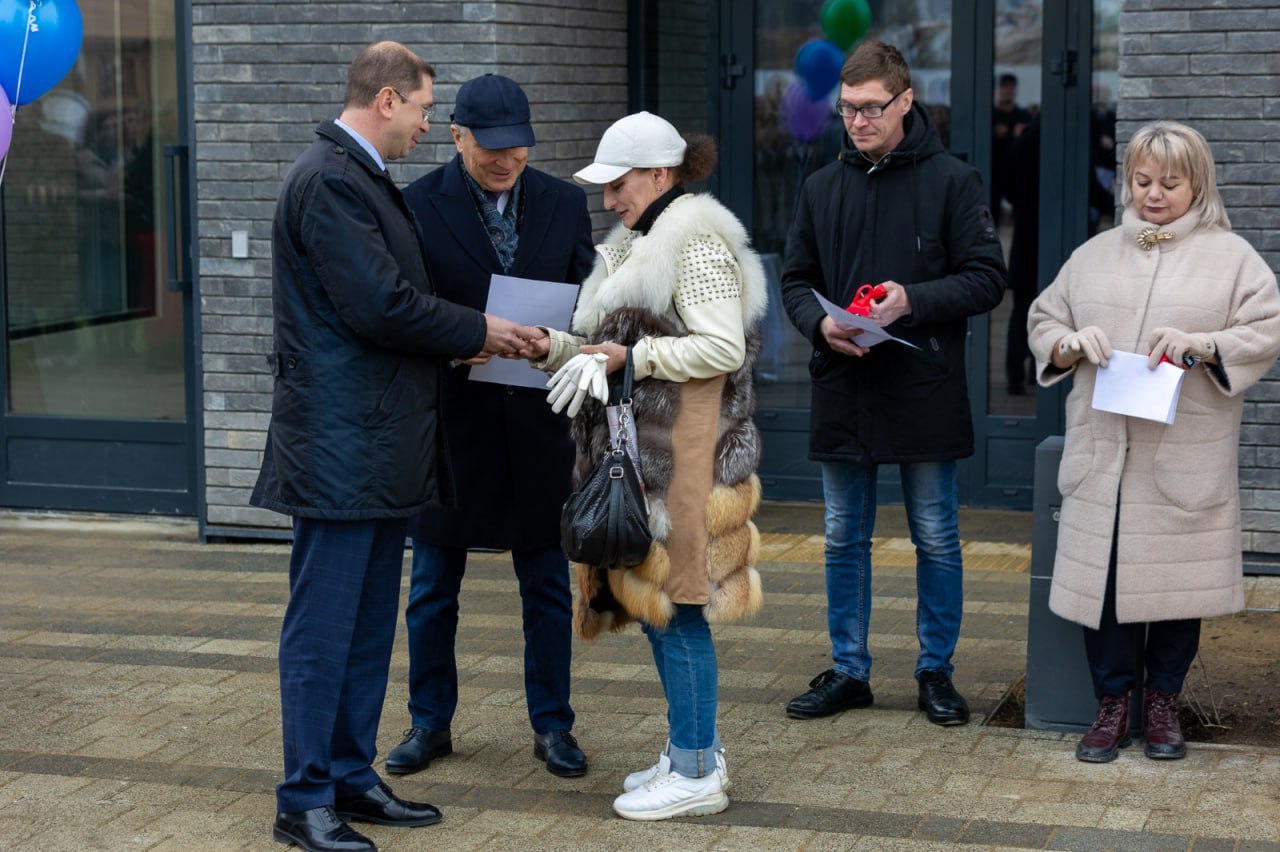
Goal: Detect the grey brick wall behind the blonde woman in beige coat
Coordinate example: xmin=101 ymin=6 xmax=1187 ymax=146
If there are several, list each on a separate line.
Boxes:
xmin=1117 ymin=0 xmax=1280 ymax=554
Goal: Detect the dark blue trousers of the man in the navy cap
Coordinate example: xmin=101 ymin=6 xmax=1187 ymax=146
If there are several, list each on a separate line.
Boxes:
xmin=404 ymin=540 xmax=573 ymax=733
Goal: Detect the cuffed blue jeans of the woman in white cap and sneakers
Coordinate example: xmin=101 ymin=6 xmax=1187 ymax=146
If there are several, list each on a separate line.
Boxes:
xmin=641 ymin=604 xmax=721 ymax=778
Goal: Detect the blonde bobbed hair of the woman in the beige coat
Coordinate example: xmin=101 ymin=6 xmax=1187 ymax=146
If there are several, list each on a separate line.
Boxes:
xmin=1121 ymin=122 xmax=1231 ymax=230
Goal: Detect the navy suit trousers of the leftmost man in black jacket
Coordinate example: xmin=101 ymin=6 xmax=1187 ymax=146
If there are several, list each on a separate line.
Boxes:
xmin=275 ymin=518 xmax=406 ymax=812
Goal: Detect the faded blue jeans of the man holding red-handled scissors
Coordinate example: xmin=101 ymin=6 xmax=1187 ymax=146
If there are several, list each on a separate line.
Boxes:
xmin=822 ymin=462 xmax=964 ymax=682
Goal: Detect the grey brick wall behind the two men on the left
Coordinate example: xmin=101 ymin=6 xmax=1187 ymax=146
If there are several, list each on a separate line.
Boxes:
xmin=192 ymin=0 xmax=627 ymax=535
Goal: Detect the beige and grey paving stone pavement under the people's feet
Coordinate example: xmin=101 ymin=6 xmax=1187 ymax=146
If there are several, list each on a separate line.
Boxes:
xmin=0 ymin=504 xmax=1280 ymax=852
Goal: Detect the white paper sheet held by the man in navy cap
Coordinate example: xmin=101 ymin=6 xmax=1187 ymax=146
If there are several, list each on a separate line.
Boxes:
xmin=470 ymin=275 xmax=577 ymax=390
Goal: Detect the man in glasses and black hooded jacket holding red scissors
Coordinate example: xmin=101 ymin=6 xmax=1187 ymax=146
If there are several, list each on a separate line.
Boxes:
xmin=782 ymin=41 xmax=1006 ymax=725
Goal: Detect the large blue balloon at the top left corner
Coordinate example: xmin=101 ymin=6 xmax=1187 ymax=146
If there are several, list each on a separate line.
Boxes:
xmin=0 ymin=0 xmax=84 ymax=105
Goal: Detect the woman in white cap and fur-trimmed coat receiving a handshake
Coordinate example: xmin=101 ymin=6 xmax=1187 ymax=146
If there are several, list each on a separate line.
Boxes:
xmin=529 ymin=113 xmax=768 ymax=820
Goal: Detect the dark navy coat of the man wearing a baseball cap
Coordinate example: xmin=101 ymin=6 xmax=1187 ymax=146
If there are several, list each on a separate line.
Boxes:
xmin=404 ymin=157 xmax=595 ymax=550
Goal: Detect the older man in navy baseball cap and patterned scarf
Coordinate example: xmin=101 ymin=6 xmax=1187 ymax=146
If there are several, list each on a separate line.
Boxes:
xmin=387 ymin=74 xmax=594 ymax=778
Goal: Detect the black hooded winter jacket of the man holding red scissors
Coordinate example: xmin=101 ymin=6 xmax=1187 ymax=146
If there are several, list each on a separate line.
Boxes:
xmin=782 ymin=105 xmax=1006 ymax=463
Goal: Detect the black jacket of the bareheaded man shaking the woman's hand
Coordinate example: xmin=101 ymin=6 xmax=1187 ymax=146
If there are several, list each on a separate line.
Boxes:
xmin=251 ymin=122 xmax=485 ymax=521
